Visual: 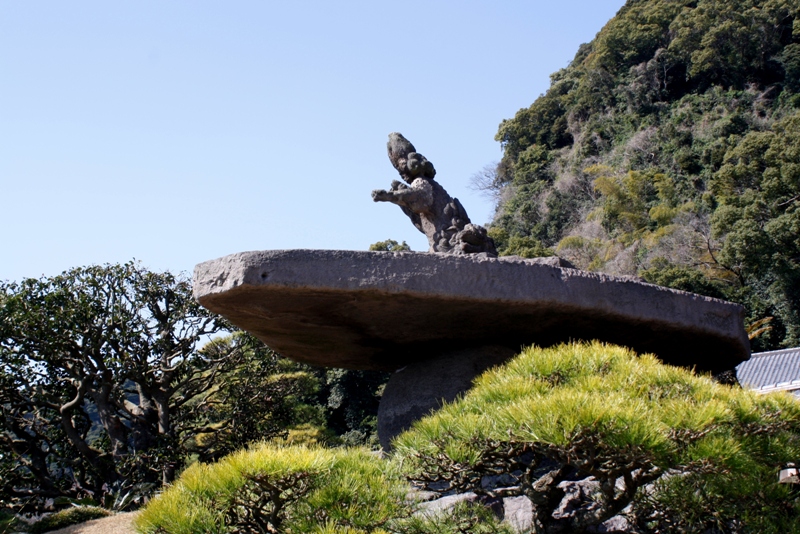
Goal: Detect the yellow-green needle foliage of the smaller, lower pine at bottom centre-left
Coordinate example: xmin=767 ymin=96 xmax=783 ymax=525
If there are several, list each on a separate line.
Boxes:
xmin=136 ymin=443 xmax=406 ymax=534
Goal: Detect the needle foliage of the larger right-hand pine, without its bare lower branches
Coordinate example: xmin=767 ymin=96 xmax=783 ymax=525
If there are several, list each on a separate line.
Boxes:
xmin=395 ymin=342 xmax=800 ymax=532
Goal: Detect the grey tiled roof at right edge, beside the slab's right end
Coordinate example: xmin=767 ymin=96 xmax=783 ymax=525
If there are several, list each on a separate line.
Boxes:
xmin=736 ymin=347 xmax=800 ymax=389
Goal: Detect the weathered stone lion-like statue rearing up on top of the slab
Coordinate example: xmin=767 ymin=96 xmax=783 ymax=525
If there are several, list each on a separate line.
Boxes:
xmin=372 ymin=132 xmax=497 ymax=256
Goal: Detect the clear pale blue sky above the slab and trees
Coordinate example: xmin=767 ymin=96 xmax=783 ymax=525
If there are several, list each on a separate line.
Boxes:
xmin=0 ymin=0 xmax=624 ymax=280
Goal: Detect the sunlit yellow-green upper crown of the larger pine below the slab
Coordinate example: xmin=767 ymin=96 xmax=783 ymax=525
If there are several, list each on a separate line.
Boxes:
xmin=396 ymin=342 xmax=800 ymax=459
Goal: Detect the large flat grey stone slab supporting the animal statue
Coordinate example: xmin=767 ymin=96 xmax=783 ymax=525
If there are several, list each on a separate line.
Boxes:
xmin=194 ymin=250 xmax=749 ymax=372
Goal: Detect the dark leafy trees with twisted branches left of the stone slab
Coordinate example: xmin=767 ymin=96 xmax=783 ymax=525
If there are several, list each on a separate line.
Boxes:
xmin=0 ymin=263 xmax=314 ymax=506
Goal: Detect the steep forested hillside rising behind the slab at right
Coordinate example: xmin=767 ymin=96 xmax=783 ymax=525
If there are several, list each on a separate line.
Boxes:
xmin=488 ymin=0 xmax=800 ymax=350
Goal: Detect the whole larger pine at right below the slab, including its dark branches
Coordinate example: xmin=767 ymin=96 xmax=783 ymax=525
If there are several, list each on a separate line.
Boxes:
xmin=395 ymin=343 xmax=800 ymax=533
